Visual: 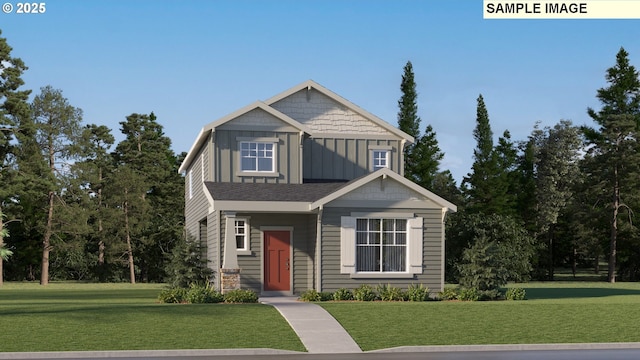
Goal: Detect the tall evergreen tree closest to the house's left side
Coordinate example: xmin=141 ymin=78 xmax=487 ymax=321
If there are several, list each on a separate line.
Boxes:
xmin=113 ymin=113 xmax=184 ymax=281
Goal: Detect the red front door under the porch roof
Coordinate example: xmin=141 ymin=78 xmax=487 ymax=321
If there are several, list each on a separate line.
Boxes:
xmin=264 ymin=230 xmax=291 ymax=291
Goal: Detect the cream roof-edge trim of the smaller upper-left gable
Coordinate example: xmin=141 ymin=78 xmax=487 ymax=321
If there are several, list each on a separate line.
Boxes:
xmin=178 ymin=101 xmax=312 ymax=173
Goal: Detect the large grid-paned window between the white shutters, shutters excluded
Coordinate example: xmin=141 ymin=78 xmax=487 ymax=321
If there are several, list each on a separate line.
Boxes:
xmin=356 ymin=219 xmax=407 ymax=272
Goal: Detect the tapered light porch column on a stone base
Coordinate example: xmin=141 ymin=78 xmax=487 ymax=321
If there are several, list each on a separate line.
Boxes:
xmin=220 ymin=212 xmax=240 ymax=294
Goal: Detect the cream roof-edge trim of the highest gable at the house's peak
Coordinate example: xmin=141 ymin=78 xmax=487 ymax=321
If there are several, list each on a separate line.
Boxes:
xmin=264 ymin=80 xmax=415 ymax=143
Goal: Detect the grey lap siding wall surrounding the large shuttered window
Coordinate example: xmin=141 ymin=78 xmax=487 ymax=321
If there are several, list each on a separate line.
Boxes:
xmin=321 ymin=207 xmax=442 ymax=292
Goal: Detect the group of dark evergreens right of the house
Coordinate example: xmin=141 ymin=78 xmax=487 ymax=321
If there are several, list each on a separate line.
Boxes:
xmin=398 ymin=48 xmax=640 ymax=291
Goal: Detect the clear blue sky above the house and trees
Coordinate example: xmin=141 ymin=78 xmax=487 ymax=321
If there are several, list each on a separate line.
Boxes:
xmin=0 ymin=0 xmax=640 ymax=183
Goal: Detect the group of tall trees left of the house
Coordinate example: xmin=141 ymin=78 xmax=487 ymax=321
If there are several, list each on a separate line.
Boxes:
xmin=0 ymin=33 xmax=184 ymax=285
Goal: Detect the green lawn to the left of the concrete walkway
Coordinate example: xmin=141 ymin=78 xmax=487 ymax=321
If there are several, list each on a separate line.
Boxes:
xmin=0 ymin=283 xmax=305 ymax=352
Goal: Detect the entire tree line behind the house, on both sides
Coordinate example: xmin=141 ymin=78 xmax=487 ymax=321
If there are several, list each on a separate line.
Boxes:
xmin=0 ymin=27 xmax=640 ymax=290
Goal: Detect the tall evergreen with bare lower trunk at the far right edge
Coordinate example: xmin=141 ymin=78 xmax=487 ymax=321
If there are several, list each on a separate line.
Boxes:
xmin=583 ymin=48 xmax=640 ymax=282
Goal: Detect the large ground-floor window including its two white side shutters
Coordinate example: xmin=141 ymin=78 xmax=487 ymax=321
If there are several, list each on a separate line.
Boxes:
xmin=340 ymin=213 xmax=424 ymax=278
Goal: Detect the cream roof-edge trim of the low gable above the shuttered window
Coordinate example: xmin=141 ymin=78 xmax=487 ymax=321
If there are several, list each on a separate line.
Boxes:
xmin=310 ymin=168 xmax=458 ymax=212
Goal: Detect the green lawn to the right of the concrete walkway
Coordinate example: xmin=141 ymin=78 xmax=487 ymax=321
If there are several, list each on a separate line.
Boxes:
xmin=321 ymin=282 xmax=640 ymax=350
